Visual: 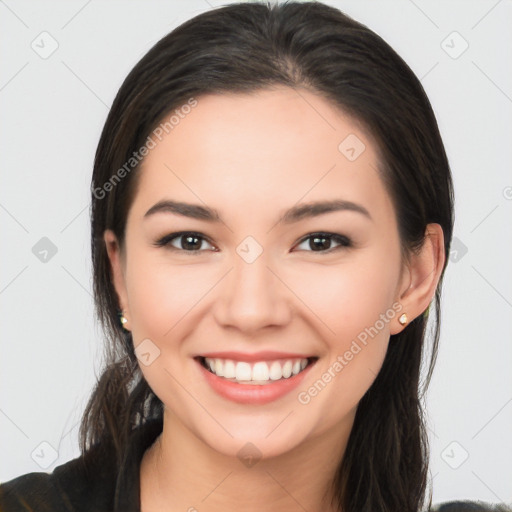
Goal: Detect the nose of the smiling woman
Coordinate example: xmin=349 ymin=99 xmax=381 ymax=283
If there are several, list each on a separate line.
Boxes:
xmin=214 ymin=253 xmax=292 ymax=335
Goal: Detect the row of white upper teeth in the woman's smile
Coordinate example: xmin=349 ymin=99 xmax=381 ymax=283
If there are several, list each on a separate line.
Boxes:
xmin=205 ymin=357 xmax=308 ymax=383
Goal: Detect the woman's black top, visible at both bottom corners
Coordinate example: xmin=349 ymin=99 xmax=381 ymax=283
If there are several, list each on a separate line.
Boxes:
xmin=0 ymin=419 xmax=510 ymax=512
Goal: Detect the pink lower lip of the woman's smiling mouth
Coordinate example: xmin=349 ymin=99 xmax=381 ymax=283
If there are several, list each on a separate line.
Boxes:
xmin=196 ymin=360 xmax=316 ymax=404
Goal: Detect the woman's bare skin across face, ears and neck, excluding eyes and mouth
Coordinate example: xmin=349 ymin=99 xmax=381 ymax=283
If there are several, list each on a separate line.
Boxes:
xmin=104 ymin=87 xmax=444 ymax=512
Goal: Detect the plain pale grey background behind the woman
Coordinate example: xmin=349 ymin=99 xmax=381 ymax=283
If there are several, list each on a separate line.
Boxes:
xmin=0 ymin=0 xmax=512 ymax=502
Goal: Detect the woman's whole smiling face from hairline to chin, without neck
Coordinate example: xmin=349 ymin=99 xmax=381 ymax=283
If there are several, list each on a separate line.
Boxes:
xmin=106 ymin=88 xmax=407 ymax=456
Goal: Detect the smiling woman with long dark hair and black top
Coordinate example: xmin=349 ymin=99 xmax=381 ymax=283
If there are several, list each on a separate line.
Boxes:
xmin=0 ymin=2 xmax=500 ymax=512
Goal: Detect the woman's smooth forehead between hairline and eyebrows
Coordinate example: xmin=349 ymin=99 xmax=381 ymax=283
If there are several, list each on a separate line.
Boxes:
xmin=133 ymin=87 xmax=391 ymax=226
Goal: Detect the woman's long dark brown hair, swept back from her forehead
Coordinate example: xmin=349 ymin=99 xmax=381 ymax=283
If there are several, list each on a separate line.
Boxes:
xmin=80 ymin=2 xmax=453 ymax=512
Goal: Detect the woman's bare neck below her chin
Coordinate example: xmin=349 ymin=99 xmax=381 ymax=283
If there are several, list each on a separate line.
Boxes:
xmin=140 ymin=409 xmax=353 ymax=512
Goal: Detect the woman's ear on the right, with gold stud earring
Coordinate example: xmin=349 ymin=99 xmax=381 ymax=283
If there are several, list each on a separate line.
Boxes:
xmin=390 ymin=224 xmax=445 ymax=334
